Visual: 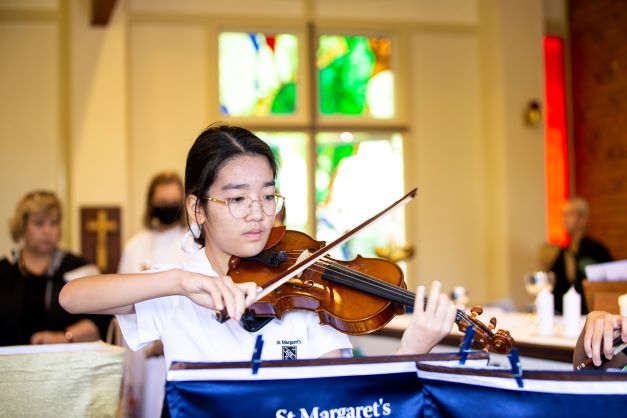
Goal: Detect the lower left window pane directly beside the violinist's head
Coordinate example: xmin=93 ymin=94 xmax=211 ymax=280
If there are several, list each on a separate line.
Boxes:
xmin=256 ymin=132 xmax=309 ymax=231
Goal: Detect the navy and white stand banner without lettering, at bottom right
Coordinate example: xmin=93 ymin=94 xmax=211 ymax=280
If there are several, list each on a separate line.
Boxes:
xmin=414 ymin=364 xmax=627 ymax=418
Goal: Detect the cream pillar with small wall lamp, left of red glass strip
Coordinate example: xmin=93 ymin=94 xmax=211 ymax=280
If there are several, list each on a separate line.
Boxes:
xmin=479 ymin=0 xmax=546 ymax=306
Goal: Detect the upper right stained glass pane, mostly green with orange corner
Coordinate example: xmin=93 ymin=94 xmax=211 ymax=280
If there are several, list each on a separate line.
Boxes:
xmin=316 ymin=35 xmax=394 ymax=119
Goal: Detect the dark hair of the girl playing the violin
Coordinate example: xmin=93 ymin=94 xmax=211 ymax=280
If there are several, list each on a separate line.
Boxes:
xmin=185 ymin=125 xmax=277 ymax=245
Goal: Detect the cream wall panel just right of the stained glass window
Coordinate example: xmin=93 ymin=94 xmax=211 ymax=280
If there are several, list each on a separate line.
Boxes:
xmin=406 ymin=31 xmax=487 ymax=300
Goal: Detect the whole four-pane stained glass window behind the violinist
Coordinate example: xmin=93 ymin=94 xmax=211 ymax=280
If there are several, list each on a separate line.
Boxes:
xmin=219 ymin=32 xmax=406 ymax=259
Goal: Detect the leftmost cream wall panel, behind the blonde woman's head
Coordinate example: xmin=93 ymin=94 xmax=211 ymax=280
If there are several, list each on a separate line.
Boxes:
xmin=0 ymin=9 xmax=62 ymax=254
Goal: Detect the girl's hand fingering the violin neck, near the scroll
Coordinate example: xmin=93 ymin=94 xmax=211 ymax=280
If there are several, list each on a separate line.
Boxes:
xmin=397 ymin=281 xmax=457 ymax=354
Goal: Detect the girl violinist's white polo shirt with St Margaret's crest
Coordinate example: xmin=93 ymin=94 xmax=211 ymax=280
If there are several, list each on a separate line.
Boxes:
xmin=117 ymin=249 xmax=352 ymax=368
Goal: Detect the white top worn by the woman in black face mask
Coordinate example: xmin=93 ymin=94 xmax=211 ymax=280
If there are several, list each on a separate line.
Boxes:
xmin=118 ymin=225 xmax=190 ymax=273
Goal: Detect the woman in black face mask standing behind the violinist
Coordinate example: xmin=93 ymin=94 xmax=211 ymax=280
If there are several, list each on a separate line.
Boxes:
xmin=118 ymin=171 xmax=186 ymax=417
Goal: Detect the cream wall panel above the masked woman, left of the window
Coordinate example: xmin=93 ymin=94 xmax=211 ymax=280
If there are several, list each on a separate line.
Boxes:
xmin=129 ymin=23 xmax=211 ymax=235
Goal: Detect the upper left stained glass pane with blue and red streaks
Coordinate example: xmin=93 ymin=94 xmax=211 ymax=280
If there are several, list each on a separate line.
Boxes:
xmin=219 ymin=32 xmax=298 ymax=117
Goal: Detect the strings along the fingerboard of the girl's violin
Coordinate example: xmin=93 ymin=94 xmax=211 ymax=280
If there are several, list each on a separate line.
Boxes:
xmin=278 ymin=251 xmax=491 ymax=333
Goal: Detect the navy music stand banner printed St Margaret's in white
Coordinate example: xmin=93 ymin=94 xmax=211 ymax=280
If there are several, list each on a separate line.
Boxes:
xmin=166 ymin=356 xmax=476 ymax=418
